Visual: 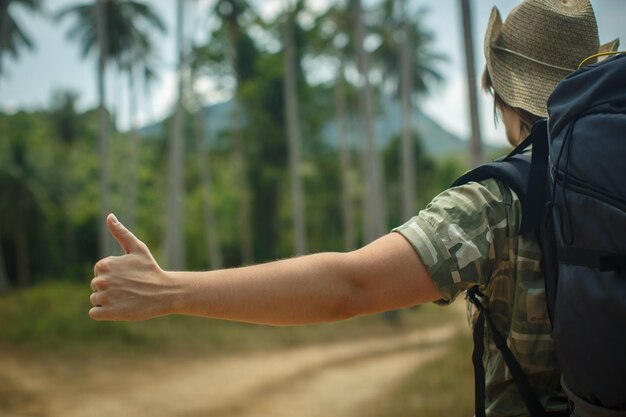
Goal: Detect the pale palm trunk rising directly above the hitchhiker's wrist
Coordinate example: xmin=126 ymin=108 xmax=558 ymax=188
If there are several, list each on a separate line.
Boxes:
xmin=165 ymin=0 xmax=185 ymax=270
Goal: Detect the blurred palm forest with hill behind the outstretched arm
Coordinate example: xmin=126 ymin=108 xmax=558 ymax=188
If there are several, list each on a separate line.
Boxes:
xmin=0 ymin=0 xmax=508 ymax=290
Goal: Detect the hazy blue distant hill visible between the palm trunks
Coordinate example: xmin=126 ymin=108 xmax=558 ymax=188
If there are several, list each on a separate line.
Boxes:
xmin=140 ymin=100 xmax=493 ymax=157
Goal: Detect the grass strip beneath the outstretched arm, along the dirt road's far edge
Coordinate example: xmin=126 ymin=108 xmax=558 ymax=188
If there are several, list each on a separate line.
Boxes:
xmin=0 ymin=283 xmax=466 ymax=354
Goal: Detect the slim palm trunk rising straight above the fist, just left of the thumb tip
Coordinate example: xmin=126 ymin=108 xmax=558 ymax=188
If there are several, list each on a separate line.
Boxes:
xmin=96 ymin=0 xmax=110 ymax=258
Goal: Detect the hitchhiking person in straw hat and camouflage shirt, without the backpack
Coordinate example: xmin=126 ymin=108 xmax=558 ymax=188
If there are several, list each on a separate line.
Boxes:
xmin=89 ymin=0 xmax=616 ymax=416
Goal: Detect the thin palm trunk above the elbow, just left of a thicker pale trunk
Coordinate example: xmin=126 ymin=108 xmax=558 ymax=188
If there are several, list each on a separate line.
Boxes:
xmin=335 ymin=54 xmax=356 ymax=251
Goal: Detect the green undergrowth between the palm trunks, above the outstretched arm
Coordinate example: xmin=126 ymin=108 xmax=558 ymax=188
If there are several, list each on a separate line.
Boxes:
xmin=0 ymin=91 xmax=472 ymax=285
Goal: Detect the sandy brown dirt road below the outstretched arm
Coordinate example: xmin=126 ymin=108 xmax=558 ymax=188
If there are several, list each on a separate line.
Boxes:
xmin=0 ymin=316 xmax=459 ymax=417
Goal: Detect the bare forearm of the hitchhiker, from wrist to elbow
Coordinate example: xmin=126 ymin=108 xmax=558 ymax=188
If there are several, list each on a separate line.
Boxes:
xmin=167 ymin=253 xmax=369 ymax=325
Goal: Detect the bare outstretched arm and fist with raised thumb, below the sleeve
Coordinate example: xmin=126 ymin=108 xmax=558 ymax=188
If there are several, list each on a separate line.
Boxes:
xmin=89 ymin=215 xmax=441 ymax=325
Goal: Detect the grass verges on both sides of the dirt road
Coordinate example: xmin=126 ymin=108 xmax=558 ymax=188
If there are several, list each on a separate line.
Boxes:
xmin=0 ymin=283 xmax=473 ymax=417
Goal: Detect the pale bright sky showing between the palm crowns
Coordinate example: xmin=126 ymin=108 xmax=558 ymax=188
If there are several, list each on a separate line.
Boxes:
xmin=0 ymin=0 xmax=626 ymax=144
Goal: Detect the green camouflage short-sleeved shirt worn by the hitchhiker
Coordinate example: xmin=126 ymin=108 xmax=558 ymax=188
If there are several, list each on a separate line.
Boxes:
xmin=394 ymin=179 xmax=567 ymax=417
